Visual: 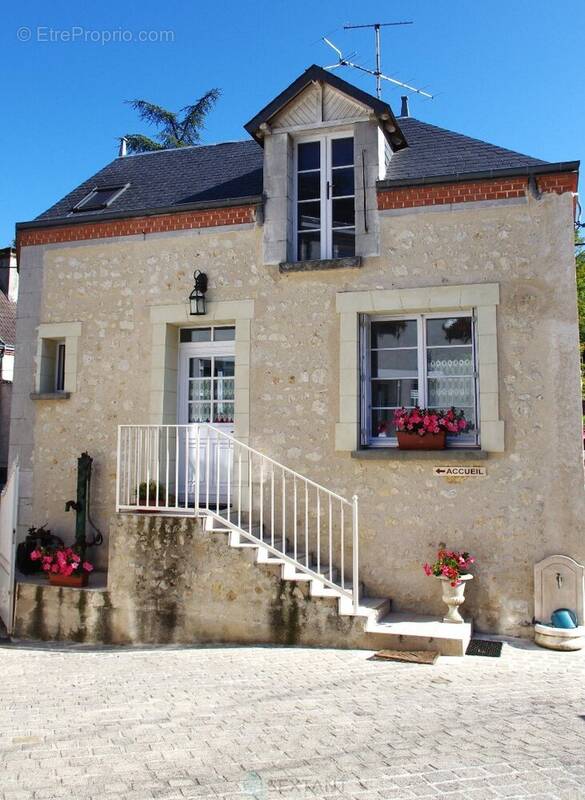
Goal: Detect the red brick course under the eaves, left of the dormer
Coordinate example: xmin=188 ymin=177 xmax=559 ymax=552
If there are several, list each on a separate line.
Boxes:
xmin=17 ymin=205 xmax=255 ymax=247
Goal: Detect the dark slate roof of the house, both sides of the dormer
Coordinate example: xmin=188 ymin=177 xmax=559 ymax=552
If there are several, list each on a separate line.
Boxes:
xmin=28 ymin=108 xmax=578 ymax=227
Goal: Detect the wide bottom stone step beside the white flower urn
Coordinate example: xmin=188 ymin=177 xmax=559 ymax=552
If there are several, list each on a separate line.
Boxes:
xmin=366 ymin=611 xmax=473 ymax=656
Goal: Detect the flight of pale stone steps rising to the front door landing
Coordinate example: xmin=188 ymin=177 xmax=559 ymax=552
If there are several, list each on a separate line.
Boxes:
xmin=204 ymin=510 xmax=472 ymax=656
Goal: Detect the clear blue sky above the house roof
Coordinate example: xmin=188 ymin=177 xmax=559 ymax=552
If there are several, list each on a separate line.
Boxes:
xmin=0 ymin=0 xmax=585 ymax=246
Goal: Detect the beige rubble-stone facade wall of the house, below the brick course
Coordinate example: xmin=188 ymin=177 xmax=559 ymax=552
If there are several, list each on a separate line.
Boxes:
xmin=13 ymin=193 xmax=585 ymax=634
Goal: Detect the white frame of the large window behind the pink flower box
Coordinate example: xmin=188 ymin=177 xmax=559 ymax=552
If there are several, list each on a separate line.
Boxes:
xmin=360 ymin=310 xmax=480 ymax=448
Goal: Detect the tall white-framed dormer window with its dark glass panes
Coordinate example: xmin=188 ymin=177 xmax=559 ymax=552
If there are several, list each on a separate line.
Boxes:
xmin=295 ymin=133 xmax=355 ymax=261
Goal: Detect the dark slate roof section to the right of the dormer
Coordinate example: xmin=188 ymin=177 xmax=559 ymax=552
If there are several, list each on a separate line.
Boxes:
xmin=386 ymin=117 xmax=548 ymax=181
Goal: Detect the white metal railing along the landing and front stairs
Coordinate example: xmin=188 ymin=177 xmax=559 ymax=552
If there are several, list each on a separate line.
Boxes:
xmin=116 ymin=424 xmax=360 ymax=608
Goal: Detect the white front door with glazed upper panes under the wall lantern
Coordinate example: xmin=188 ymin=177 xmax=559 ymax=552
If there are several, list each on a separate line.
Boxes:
xmin=178 ymin=328 xmax=235 ymax=506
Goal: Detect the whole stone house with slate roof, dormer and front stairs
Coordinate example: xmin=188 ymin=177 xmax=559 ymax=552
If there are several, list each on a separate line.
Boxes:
xmin=6 ymin=66 xmax=585 ymax=652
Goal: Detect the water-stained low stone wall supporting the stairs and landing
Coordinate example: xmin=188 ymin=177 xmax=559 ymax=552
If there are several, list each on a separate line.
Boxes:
xmin=14 ymin=515 xmax=375 ymax=647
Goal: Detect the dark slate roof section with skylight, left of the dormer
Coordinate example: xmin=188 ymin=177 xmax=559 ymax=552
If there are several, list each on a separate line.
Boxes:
xmin=37 ymin=139 xmax=263 ymax=220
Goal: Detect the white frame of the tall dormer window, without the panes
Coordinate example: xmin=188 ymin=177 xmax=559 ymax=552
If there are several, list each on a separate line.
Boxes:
xmin=292 ymin=129 xmax=356 ymax=261
